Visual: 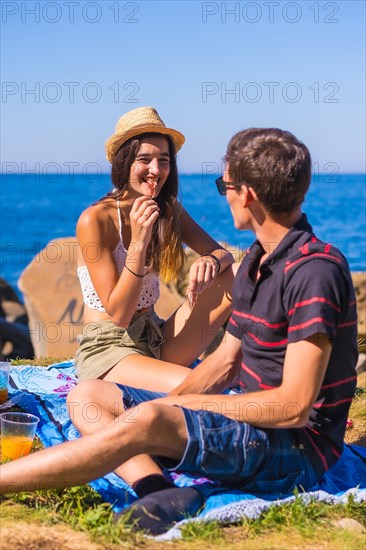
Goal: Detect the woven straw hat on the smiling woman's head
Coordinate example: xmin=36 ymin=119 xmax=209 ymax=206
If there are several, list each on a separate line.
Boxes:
xmin=105 ymin=107 xmax=185 ymax=162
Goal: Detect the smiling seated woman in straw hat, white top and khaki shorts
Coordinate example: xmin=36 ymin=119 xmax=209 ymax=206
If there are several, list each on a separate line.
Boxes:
xmin=76 ymin=107 xmax=233 ymax=392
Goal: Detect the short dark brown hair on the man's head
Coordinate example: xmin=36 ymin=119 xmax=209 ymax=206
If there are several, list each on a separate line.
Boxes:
xmin=225 ymin=128 xmax=311 ymax=216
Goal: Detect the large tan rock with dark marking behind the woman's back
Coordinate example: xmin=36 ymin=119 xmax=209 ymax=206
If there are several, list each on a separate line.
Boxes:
xmin=18 ymin=237 xmax=84 ymax=358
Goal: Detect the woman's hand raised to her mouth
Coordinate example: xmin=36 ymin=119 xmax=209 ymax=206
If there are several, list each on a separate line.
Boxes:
xmin=130 ymin=196 xmax=160 ymax=248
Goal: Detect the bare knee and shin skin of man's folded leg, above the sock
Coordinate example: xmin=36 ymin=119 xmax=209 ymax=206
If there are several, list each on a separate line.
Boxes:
xmin=67 ymin=380 xmax=162 ymax=485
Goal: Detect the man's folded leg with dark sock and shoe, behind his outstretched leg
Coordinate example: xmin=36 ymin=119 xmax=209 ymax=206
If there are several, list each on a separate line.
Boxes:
xmin=67 ymin=380 xmax=203 ymax=534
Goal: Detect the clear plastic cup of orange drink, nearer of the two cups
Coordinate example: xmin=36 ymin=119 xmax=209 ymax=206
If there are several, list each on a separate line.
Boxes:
xmin=0 ymin=412 xmax=39 ymax=462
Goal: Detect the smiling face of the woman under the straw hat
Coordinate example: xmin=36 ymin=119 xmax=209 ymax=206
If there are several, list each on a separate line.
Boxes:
xmin=129 ymin=135 xmax=170 ymax=198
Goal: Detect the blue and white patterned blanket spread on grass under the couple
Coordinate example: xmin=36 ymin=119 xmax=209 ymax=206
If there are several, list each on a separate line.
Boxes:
xmin=5 ymin=362 xmax=366 ymax=540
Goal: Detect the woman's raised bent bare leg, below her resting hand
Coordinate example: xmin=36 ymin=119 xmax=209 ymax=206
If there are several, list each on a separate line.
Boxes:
xmin=160 ymin=264 xmax=234 ymax=366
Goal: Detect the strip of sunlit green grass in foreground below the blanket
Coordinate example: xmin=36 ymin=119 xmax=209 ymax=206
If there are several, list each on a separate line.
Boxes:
xmin=0 ymin=486 xmax=366 ymax=550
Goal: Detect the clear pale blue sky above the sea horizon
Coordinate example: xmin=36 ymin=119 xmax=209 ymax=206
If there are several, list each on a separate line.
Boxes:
xmin=1 ymin=0 xmax=365 ymax=173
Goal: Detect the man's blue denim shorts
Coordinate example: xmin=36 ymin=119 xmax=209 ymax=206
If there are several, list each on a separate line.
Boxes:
xmin=118 ymin=384 xmax=321 ymax=497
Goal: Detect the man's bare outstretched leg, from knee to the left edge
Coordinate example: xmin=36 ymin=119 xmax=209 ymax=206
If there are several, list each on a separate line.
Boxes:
xmin=0 ymin=402 xmax=187 ymax=494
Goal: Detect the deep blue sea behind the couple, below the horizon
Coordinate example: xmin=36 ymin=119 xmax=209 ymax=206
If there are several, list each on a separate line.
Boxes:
xmin=0 ymin=174 xmax=366 ymax=295
